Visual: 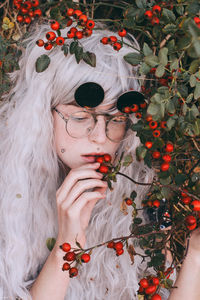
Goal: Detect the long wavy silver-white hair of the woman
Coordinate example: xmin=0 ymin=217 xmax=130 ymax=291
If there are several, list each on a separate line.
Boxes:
xmin=0 ymin=24 xmax=169 ymax=300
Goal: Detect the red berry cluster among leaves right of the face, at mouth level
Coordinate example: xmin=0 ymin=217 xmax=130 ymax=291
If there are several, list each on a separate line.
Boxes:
xmin=145 ymin=137 xmax=174 ymax=172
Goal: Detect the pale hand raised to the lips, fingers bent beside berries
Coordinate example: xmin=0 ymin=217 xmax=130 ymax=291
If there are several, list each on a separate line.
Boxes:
xmin=56 ymin=163 xmax=107 ymax=247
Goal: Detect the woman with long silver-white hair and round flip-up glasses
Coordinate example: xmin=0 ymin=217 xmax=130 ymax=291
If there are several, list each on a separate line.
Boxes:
xmin=0 ymin=23 xmax=170 ymax=300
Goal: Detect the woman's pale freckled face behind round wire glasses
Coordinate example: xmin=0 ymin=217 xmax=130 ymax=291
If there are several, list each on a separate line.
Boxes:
xmin=52 ymin=103 xmax=121 ymax=169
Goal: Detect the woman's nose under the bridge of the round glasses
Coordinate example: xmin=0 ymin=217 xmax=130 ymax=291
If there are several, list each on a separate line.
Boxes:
xmin=88 ymin=116 xmax=107 ymax=144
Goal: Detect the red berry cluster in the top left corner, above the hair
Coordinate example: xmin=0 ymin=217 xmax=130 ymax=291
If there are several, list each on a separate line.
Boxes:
xmin=13 ymin=0 xmax=42 ymax=24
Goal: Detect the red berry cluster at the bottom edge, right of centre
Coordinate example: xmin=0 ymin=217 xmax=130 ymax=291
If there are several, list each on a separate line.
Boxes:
xmin=138 ymin=276 xmax=162 ymax=300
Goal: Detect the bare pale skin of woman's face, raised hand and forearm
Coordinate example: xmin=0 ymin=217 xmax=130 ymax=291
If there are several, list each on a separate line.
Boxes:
xmin=30 ymin=104 xmax=120 ymax=300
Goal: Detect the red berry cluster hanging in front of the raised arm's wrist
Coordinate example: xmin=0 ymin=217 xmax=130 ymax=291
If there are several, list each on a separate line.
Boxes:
xmin=60 ymin=243 xmax=90 ymax=278
